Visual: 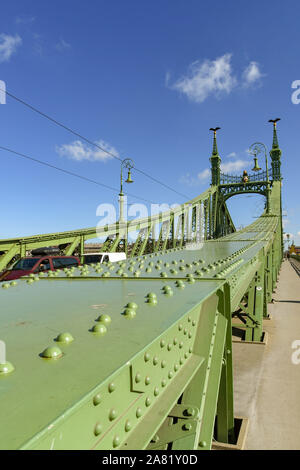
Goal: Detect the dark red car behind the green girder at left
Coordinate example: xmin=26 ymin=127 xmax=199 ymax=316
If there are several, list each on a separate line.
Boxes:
xmin=0 ymin=256 xmax=80 ymax=281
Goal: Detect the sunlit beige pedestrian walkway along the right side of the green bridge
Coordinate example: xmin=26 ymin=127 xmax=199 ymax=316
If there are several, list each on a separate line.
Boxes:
xmin=233 ymin=261 xmax=300 ymax=450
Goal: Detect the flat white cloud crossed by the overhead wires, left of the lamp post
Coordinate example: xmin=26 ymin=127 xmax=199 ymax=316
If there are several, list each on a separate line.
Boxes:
xmin=56 ymin=140 xmax=119 ymax=162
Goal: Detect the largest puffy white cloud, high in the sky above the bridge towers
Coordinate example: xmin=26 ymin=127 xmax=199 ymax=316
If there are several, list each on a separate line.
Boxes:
xmin=168 ymin=54 xmax=237 ymax=103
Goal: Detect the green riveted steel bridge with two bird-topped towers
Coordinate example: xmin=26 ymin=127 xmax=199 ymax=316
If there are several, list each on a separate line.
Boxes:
xmin=0 ymin=122 xmax=283 ymax=450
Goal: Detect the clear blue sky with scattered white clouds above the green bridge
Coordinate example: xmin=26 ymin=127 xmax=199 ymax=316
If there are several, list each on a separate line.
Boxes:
xmin=0 ymin=0 xmax=300 ymax=244
